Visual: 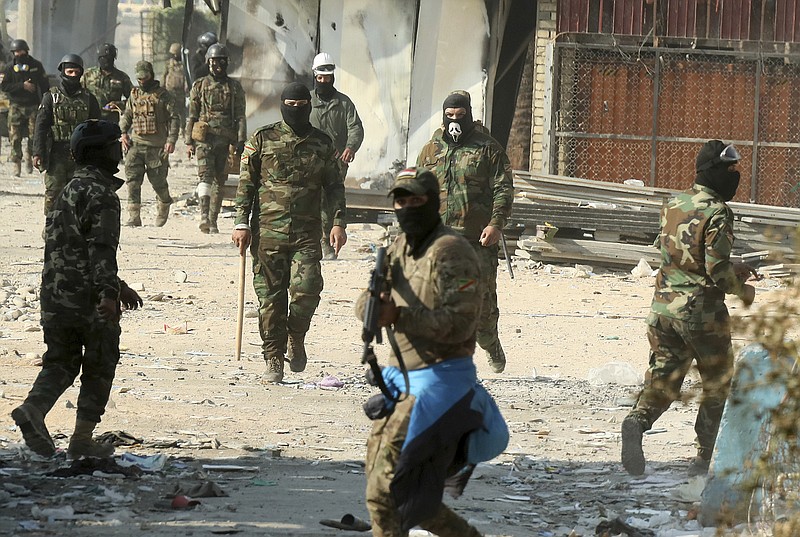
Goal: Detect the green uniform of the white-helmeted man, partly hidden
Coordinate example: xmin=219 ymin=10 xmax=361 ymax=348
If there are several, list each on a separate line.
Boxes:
xmin=311 ymin=91 xmax=364 ymax=255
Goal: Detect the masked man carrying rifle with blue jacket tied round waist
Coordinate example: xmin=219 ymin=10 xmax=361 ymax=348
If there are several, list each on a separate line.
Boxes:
xmin=356 ymin=168 xmax=508 ymax=537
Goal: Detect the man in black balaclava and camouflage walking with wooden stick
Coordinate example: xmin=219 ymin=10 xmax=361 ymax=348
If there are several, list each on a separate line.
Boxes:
xmin=231 ymin=82 xmax=347 ymax=384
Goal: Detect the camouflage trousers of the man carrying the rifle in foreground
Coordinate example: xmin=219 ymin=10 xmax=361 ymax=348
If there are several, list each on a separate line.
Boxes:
xmin=365 ymin=395 xmax=480 ymax=537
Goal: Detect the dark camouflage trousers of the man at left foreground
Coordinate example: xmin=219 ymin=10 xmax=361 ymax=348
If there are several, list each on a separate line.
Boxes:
xmin=25 ymin=322 xmax=120 ymax=423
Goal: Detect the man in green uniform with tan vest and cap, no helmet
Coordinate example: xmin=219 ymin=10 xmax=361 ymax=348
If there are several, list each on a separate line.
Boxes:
xmin=119 ymin=61 xmax=180 ymax=227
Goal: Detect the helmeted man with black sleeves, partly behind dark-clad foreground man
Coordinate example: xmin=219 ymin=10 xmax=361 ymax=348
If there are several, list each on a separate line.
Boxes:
xmin=33 ymin=54 xmax=100 ymax=214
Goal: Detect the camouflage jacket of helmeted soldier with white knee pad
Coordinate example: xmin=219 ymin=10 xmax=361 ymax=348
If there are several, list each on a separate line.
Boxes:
xmin=185 ymin=75 xmax=247 ymax=145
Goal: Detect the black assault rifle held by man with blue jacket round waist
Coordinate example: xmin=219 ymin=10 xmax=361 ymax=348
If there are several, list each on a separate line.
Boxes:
xmin=361 ymin=246 xmax=410 ymax=406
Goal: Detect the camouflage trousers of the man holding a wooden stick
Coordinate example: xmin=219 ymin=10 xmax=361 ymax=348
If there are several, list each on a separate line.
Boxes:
xmin=251 ymin=232 xmax=323 ymax=357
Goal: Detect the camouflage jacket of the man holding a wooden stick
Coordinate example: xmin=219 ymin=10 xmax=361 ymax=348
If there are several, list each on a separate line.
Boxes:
xmin=235 ymin=121 xmax=345 ymax=249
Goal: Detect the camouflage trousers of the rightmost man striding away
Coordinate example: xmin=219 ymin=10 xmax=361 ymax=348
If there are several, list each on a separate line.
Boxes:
xmin=631 ymin=312 xmax=733 ymax=459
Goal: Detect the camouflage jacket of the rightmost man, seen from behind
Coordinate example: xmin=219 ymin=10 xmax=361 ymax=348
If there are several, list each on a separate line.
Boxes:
xmin=649 ymin=184 xmax=744 ymax=323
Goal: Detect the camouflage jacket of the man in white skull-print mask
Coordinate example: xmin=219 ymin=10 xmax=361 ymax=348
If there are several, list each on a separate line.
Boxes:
xmin=417 ymin=124 xmax=514 ymax=241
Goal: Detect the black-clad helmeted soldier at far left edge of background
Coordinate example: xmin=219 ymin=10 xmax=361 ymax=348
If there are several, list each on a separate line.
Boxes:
xmin=0 ymin=39 xmax=49 ymax=177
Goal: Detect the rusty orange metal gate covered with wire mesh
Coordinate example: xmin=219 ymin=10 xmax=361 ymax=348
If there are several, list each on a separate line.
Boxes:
xmin=549 ymin=43 xmax=800 ymax=207
